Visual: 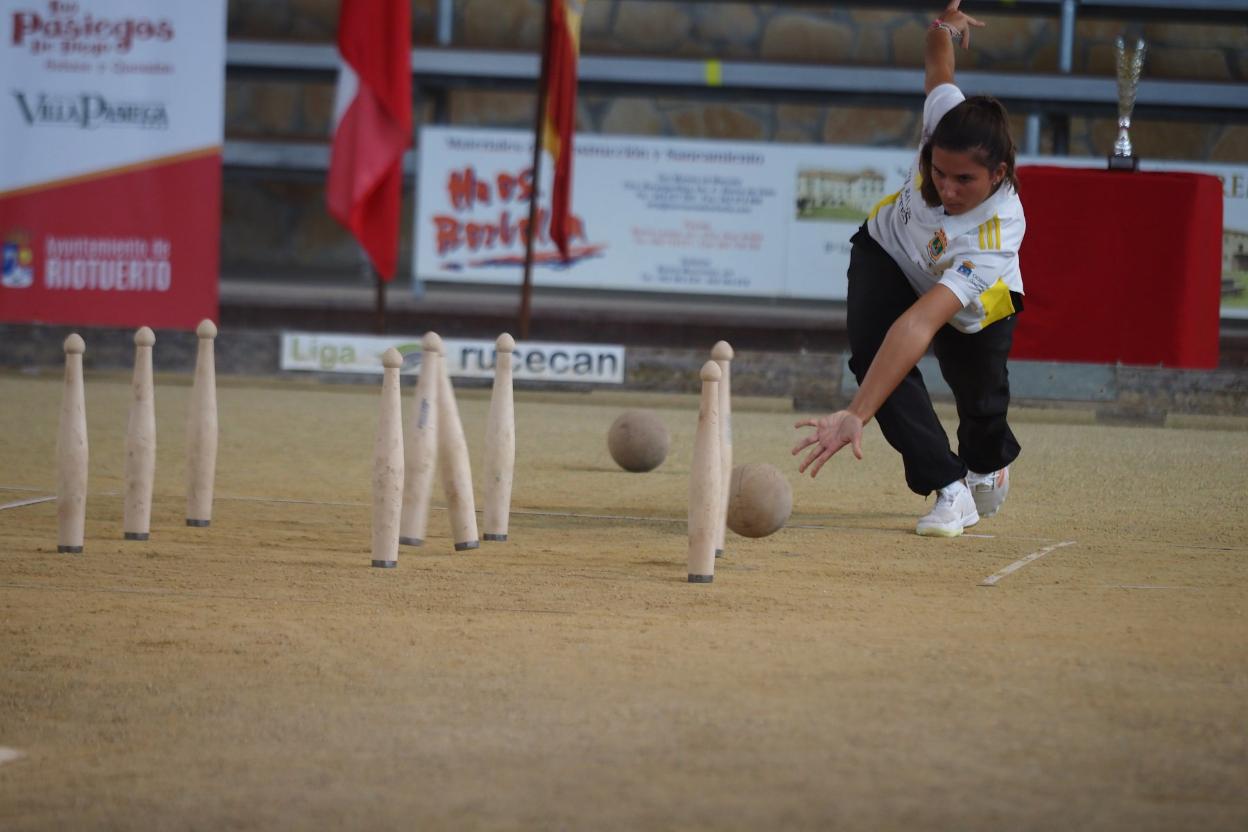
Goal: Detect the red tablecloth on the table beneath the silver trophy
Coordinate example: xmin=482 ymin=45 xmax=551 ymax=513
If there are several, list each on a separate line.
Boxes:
xmin=1011 ymin=166 xmax=1222 ymax=368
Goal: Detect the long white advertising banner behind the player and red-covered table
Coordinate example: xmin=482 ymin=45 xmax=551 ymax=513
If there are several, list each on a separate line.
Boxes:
xmin=413 ymin=127 xmax=1248 ymax=317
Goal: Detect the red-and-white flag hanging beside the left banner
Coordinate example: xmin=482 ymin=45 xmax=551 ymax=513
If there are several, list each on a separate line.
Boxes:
xmin=326 ymin=0 xmax=412 ymax=281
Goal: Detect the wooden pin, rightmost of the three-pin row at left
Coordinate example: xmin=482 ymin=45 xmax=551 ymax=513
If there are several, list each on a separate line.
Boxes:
xmin=186 ymin=319 xmax=217 ymax=526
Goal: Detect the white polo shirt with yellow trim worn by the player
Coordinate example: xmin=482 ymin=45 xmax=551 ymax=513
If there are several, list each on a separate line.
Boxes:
xmin=867 ymin=84 xmax=1027 ymax=333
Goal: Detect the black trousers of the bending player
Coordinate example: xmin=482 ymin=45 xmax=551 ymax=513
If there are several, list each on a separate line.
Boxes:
xmin=846 ymin=226 xmax=1020 ymax=495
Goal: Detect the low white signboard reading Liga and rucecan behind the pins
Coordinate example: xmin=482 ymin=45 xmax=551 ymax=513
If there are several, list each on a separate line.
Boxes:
xmin=281 ymin=332 xmax=624 ymax=384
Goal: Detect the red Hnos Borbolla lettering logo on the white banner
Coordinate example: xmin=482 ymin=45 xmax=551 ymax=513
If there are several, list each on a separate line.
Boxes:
xmin=432 ymin=160 xmax=607 ymax=272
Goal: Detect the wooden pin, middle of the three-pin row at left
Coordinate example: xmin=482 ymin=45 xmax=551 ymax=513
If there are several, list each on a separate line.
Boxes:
xmin=122 ymin=327 xmax=156 ymax=540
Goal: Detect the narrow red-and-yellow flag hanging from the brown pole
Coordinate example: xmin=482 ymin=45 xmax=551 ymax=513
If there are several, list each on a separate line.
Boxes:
xmin=542 ymin=0 xmax=584 ymax=259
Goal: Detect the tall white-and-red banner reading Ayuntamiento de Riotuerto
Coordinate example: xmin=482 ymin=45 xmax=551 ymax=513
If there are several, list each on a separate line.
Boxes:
xmin=0 ymin=0 xmax=226 ymax=329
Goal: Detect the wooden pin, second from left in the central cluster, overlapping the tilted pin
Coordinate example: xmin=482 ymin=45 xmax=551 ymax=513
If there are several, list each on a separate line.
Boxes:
xmin=398 ymin=332 xmax=442 ymax=546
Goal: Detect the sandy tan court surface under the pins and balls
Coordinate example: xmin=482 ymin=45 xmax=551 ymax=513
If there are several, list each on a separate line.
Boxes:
xmin=0 ymin=374 xmax=1248 ymax=830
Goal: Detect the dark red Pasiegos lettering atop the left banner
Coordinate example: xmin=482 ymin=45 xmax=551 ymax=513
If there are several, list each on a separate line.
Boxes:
xmin=9 ymin=0 xmax=175 ymax=57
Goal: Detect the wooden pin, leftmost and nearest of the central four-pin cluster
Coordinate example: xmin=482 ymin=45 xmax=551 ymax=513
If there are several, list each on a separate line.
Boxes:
xmin=373 ymin=347 xmax=403 ymax=569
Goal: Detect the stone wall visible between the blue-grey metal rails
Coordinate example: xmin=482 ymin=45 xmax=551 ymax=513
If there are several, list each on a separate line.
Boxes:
xmin=222 ymin=0 xmax=1248 ymax=274
